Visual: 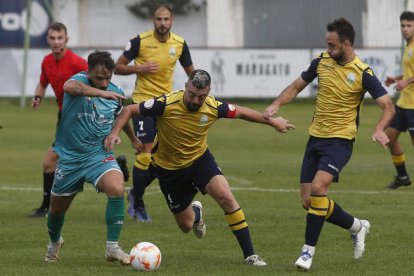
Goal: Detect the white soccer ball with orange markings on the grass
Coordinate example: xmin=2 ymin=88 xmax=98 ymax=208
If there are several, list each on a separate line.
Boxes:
xmin=129 ymin=242 xmax=161 ymax=271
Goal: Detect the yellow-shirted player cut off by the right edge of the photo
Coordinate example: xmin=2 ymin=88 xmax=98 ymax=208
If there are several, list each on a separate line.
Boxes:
xmin=385 ymin=11 xmax=414 ymax=189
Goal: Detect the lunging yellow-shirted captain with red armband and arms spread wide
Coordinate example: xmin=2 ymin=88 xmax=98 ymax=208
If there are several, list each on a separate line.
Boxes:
xmin=105 ymin=69 xmax=294 ymax=266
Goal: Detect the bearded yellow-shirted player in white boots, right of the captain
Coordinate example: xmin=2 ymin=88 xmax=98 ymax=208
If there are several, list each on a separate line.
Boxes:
xmin=263 ymin=18 xmax=395 ymax=270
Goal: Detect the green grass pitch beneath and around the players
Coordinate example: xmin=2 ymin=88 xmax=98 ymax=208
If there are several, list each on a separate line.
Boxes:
xmin=0 ymin=99 xmax=414 ymax=275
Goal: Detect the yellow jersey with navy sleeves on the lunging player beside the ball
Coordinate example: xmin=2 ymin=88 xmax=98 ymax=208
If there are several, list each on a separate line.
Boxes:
xmin=139 ymin=90 xmax=235 ymax=170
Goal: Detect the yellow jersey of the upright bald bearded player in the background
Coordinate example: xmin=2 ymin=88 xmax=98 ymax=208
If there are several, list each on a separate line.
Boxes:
xmin=123 ymin=31 xmax=193 ymax=103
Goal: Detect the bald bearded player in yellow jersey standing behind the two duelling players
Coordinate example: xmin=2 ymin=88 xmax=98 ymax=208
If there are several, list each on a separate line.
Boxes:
xmin=114 ymin=5 xmax=194 ymax=221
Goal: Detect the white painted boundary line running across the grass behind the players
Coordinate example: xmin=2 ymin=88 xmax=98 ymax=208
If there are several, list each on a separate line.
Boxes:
xmin=0 ymin=185 xmax=412 ymax=196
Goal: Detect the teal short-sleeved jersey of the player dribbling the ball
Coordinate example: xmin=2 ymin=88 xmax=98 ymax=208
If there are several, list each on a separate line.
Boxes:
xmin=53 ymin=72 xmax=124 ymax=166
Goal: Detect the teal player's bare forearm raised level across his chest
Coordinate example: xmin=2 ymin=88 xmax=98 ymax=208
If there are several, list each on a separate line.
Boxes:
xmin=63 ymin=80 xmax=127 ymax=100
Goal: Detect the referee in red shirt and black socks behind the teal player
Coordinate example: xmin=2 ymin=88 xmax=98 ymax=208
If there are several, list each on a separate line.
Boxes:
xmin=29 ymin=22 xmax=88 ymax=217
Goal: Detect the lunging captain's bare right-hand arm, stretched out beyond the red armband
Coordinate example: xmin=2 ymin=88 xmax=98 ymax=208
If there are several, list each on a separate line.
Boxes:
xmin=235 ymin=106 xmax=295 ymax=133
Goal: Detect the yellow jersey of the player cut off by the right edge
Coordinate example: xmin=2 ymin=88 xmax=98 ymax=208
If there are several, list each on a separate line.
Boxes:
xmin=397 ymin=43 xmax=414 ymax=109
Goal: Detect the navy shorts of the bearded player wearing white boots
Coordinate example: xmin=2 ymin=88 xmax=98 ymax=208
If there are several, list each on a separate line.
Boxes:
xmin=300 ymin=136 xmax=354 ymax=183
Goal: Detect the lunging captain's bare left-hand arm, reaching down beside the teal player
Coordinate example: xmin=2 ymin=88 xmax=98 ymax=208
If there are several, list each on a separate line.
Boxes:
xmin=104 ymin=104 xmax=140 ymax=151
